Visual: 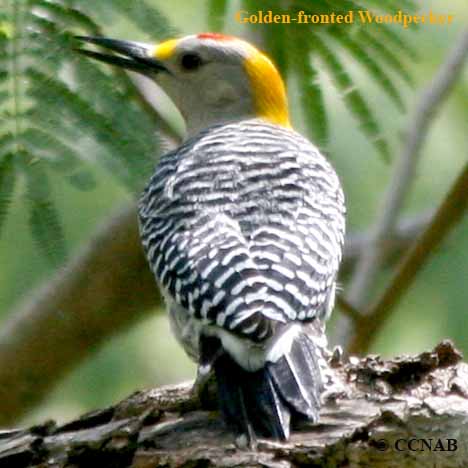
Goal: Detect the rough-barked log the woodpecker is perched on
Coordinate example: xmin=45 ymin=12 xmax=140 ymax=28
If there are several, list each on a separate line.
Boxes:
xmin=0 ymin=341 xmax=468 ymax=468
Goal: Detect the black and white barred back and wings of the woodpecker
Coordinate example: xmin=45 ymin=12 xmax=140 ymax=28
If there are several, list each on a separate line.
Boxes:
xmin=139 ymin=119 xmax=345 ymax=438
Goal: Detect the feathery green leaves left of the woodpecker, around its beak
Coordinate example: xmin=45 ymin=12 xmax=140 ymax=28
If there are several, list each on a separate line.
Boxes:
xmin=0 ymin=0 xmax=170 ymax=265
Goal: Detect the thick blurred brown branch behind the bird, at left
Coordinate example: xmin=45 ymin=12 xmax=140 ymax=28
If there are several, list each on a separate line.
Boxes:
xmin=0 ymin=206 xmax=160 ymax=424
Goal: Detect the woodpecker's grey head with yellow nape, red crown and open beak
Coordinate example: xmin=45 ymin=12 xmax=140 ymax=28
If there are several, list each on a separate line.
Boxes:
xmin=78 ymin=33 xmax=290 ymax=135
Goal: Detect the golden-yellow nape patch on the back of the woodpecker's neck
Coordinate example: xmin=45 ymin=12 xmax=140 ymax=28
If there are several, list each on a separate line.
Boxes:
xmin=244 ymin=47 xmax=291 ymax=127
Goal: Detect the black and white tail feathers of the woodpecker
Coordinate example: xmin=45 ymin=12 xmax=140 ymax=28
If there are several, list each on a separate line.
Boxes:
xmin=214 ymin=332 xmax=322 ymax=440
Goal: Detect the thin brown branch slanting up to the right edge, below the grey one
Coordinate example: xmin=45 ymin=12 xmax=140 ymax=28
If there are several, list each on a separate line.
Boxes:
xmin=349 ymin=164 xmax=468 ymax=353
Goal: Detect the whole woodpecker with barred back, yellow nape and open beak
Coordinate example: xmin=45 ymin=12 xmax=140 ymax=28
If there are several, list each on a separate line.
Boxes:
xmin=79 ymin=33 xmax=345 ymax=441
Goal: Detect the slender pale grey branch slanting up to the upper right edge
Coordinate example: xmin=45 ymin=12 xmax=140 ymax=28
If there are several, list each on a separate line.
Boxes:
xmin=347 ymin=30 xmax=468 ymax=309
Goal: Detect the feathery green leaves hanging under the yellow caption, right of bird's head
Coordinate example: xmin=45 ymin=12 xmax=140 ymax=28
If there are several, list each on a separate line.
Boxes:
xmin=242 ymin=0 xmax=416 ymax=160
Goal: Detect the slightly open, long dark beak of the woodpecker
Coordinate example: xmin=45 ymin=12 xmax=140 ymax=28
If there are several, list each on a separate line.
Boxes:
xmin=75 ymin=36 xmax=168 ymax=75
